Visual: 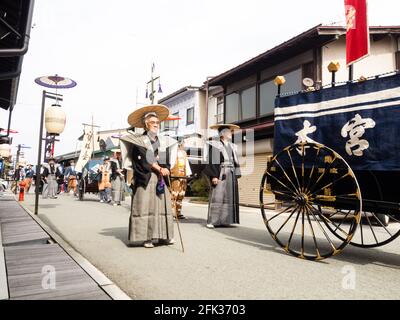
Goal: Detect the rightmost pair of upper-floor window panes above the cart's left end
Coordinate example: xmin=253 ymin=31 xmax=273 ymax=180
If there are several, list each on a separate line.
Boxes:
xmin=260 ymin=68 xmax=302 ymax=116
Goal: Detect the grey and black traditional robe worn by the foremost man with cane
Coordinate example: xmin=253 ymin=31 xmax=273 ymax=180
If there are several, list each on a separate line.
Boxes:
xmin=121 ymin=133 xmax=177 ymax=243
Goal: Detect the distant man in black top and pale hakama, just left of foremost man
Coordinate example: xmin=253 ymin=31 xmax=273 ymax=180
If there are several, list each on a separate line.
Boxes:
xmin=110 ymin=149 xmax=125 ymax=206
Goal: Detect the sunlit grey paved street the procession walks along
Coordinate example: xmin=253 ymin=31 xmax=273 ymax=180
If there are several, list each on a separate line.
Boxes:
xmin=24 ymin=194 xmax=400 ymax=299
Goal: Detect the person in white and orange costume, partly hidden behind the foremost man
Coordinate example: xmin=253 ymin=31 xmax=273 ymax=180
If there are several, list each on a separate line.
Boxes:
xmin=171 ymin=139 xmax=192 ymax=219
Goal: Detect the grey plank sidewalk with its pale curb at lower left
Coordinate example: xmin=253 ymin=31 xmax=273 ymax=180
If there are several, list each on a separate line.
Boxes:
xmin=0 ymin=192 xmax=129 ymax=300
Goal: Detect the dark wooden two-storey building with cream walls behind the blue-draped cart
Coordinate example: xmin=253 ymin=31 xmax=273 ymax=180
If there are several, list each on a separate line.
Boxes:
xmin=205 ymin=25 xmax=400 ymax=206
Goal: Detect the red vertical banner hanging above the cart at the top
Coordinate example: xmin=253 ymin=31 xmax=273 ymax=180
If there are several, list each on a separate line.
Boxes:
xmin=344 ymin=0 xmax=369 ymax=66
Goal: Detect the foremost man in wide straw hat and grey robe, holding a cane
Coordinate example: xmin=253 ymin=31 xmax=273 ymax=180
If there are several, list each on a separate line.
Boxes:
xmin=121 ymin=105 xmax=177 ymax=248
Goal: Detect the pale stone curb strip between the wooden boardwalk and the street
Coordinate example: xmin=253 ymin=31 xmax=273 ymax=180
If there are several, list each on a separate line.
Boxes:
xmin=16 ymin=200 xmax=132 ymax=300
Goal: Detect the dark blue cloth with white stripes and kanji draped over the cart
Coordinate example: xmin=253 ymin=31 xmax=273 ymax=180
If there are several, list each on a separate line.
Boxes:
xmin=274 ymin=74 xmax=400 ymax=170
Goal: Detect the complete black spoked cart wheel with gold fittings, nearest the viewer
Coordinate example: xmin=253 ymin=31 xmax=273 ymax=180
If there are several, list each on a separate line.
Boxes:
xmin=260 ymin=143 xmax=362 ymax=260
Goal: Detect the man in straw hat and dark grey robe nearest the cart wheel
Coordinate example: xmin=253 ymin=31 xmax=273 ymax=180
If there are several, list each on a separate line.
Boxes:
xmin=203 ymin=124 xmax=240 ymax=228
